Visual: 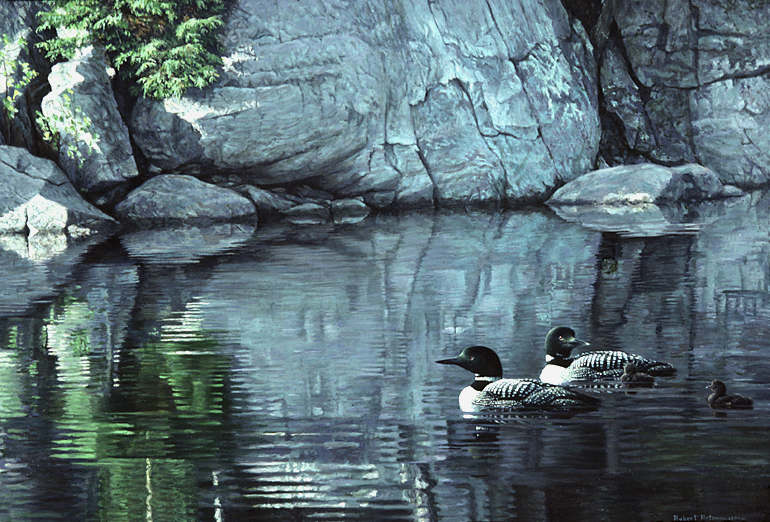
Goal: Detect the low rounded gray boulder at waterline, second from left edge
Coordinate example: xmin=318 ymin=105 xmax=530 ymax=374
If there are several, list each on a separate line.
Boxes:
xmin=115 ymin=174 xmax=256 ymax=225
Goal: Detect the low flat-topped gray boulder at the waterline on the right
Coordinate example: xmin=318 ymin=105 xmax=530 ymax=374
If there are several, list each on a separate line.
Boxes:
xmin=548 ymin=163 xmax=736 ymax=207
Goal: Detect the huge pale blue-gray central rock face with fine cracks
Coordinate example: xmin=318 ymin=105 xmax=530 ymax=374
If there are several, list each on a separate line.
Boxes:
xmin=129 ymin=0 xmax=599 ymax=208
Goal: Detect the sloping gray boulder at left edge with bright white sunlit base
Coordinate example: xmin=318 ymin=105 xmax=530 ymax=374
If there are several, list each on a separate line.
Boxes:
xmin=0 ymin=145 xmax=117 ymax=236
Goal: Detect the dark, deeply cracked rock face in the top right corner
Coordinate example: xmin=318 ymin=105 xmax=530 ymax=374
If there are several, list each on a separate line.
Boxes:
xmin=600 ymin=0 xmax=770 ymax=188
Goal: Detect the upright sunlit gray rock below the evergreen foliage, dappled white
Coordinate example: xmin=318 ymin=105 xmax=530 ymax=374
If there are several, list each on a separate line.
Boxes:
xmin=41 ymin=47 xmax=138 ymax=205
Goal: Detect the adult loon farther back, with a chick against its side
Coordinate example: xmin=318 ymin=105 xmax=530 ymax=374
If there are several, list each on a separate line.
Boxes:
xmin=540 ymin=326 xmax=676 ymax=384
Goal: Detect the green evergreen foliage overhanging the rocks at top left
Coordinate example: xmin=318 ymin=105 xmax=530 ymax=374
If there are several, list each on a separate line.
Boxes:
xmin=39 ymin=0 xmax=225 ymax=98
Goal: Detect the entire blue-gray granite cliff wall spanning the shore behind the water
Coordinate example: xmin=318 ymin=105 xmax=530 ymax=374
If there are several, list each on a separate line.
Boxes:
xmin=0 ymin=0 xmax=770 ymax=228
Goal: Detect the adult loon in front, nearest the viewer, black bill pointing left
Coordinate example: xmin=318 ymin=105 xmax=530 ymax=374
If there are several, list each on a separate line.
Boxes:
xmin=436 ymin=346 xmax=601 ymax=412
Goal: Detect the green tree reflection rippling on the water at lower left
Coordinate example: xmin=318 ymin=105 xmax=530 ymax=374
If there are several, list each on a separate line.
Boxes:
xmin=0 ymin=289 xmax=229 ymax=522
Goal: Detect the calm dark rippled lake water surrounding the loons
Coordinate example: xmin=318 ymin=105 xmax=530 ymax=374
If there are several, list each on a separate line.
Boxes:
xmin=0 ymin=194 xmax=770 ymax=522
